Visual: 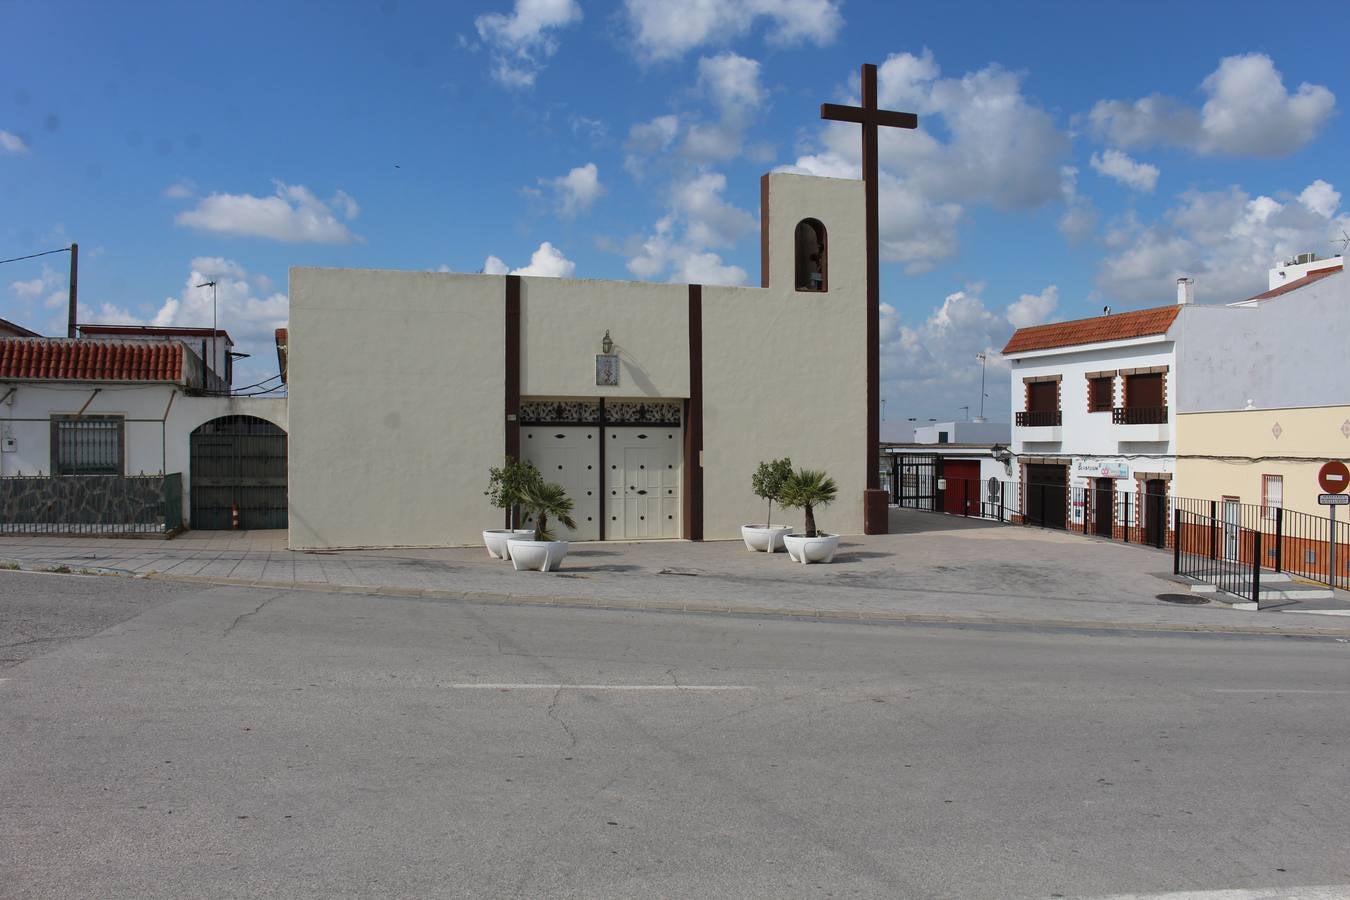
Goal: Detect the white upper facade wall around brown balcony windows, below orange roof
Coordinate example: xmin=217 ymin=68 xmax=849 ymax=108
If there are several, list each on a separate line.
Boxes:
xmin=1008 ymin=337 xmax=1191 ymax=490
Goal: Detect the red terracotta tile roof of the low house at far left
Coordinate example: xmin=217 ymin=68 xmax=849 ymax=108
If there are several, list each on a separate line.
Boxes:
xmin=0 ymin=337 xmax=185 ymax=383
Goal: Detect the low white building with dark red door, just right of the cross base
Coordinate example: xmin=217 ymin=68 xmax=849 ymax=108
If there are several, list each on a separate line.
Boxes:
xmin=882 ymin=421 xmax=1011 ymax=518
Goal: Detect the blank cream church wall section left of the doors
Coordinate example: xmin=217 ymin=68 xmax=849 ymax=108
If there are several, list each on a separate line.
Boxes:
xmin=289 ymin=269 xmax=506 ymax=549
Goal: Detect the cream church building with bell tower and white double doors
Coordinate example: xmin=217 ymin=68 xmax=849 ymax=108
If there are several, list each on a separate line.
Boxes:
xmin=288 ymin=174 xmax=876 ymax=549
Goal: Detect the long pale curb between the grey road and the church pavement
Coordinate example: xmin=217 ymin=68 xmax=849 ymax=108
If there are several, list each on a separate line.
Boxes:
xmin=134 ymin=573 xmax=1350 ymax=638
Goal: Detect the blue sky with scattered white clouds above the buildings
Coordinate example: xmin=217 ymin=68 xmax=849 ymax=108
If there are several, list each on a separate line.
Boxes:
xmin=0 ymin=0 xmax=1350 ymax=421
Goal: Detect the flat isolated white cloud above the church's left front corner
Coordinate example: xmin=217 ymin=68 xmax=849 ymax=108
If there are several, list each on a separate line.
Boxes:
xmin=174 ymin=181 xmax=359 ymax=244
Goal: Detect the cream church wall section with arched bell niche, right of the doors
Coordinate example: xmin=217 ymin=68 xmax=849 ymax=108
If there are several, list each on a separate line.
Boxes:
xmin=703 ymin=174 xmax=867 ymax=538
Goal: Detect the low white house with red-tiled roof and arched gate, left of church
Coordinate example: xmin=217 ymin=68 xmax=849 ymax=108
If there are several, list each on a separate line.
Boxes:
xmin=0 ymin=329 xmax=286 ymax=532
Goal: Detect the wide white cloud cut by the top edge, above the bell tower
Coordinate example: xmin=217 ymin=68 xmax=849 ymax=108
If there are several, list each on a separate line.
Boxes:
xmin=624 ymin=0 xmax=844 ymax=61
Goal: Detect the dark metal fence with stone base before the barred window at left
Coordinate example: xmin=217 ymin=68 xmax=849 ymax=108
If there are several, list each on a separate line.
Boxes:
xmin=0 ymin=472 xmax=182 ymax=534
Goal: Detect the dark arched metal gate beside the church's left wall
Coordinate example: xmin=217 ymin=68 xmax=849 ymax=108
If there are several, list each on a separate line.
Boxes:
xmin=189 ymin=416 xmax=286 ymax=530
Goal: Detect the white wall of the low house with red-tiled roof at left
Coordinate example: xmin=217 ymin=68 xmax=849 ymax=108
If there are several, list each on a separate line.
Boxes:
xmin=0 ymin=381 xmax=289 ymax=521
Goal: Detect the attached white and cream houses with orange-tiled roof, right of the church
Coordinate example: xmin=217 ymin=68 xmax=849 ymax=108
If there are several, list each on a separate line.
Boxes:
xmin=1003 ymin=254 xmax=1350 ymax=542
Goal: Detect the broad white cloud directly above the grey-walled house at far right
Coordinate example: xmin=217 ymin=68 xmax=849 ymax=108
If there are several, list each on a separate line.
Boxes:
xmin=1098 ymin=179 xmax=1350 ymax=304
